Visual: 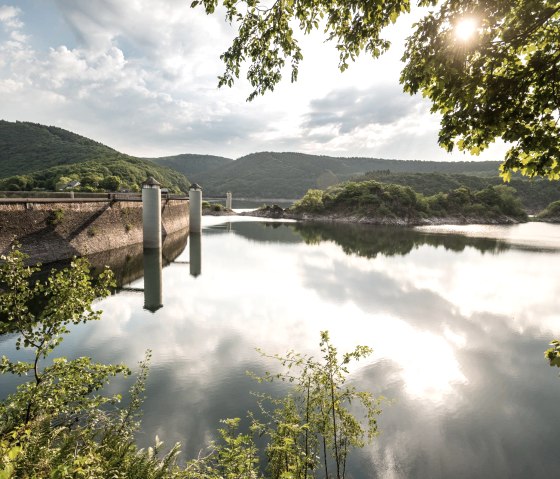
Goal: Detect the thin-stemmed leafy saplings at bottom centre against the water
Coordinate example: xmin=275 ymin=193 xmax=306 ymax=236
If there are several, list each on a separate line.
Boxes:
xmin=248 ymin=331 xmax=381 ymax=479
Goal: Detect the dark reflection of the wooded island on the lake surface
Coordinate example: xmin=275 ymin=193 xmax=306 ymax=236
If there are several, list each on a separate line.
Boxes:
xmin=291 ymin=223 xmax=509 ymax=258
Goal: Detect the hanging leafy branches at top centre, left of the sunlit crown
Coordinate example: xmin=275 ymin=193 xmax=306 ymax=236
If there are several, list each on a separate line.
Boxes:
xmin=191 ymin=0 xmax=410 ymax=100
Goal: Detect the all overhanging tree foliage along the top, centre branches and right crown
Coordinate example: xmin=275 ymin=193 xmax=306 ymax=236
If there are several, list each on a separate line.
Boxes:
xmin=192 ymin=0 xmax=560 ymax=180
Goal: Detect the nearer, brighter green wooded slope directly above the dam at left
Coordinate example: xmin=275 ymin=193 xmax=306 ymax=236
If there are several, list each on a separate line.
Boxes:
xmin=0 ymin=155 xmax=190 ymax=193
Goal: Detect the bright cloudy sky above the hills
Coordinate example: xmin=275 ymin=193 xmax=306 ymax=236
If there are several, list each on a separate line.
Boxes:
xmin=0 ymin=0 xmax=506 ymax=161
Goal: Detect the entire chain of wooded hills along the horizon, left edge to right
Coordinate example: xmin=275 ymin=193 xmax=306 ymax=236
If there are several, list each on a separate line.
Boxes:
xmin=0 ymin=120 xmax=508 ymax=199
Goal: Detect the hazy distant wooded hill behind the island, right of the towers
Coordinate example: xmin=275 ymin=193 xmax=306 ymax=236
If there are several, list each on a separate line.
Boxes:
xmin=195 ymin=152 xmax=500 ymax=198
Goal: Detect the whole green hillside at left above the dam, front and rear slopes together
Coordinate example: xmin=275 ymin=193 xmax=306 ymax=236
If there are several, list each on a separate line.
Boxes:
xmin=0 ymin=120 xmax=190 ymax=192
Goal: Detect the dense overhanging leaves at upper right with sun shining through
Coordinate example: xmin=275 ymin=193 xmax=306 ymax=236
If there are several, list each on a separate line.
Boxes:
xmin=401 ymin=0 xmax=560 ymax=179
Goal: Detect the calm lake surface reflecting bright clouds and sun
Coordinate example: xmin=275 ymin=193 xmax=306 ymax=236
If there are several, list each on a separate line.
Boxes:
xmin=0 ymin=218 xmax=560 ymax=478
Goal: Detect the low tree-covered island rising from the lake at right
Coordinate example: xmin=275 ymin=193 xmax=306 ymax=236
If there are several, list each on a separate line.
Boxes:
xmin=290 ymin=180 xmax=527 ymax=224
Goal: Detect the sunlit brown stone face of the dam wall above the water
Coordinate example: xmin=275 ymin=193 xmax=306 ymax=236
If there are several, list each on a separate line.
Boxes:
xmin=0 ymin=199 xmax=189 ymax=263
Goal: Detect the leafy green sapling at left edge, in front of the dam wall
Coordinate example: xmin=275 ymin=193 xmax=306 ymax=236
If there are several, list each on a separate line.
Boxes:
xmin=0 ymin=249 xmax=126 ymax=432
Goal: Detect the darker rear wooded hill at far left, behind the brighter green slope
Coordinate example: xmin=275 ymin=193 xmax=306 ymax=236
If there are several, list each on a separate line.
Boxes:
xmin=0 ymin=120 xmax=122 ymax=178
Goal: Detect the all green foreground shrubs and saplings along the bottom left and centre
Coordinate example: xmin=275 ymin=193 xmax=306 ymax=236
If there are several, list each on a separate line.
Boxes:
xmin=0 ymin=250 xmax=381 ymax=479
